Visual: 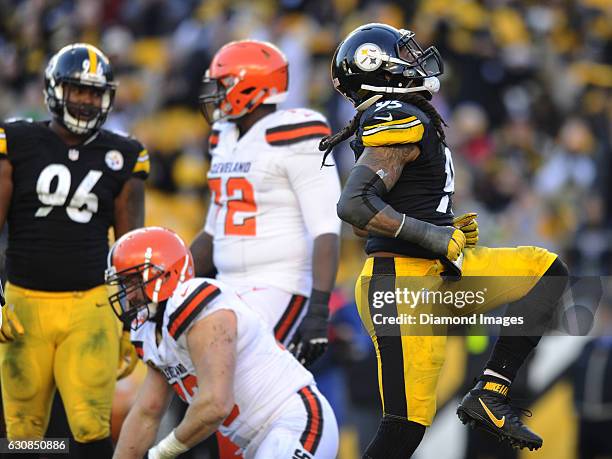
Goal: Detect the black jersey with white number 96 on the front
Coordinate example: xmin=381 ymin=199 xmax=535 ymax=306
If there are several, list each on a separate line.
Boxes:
xmin=0 ymin=121 xmax=149 ymax=291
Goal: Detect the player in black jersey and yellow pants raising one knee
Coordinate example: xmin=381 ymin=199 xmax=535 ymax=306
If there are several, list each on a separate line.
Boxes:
xmin=321 ymin=24 xmax=567 ymax=459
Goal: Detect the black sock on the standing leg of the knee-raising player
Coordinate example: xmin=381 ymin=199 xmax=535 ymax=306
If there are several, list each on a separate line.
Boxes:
xmin=363 ymin=415 xmax=425 ymax=459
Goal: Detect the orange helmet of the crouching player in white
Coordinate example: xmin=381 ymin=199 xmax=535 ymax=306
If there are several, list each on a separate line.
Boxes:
xmin=105 ymin=227 xmax=195 ymax=328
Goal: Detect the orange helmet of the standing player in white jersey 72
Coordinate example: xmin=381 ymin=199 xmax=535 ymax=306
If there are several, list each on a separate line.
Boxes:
xmin=199 ymin=40 xmax=289 ymax=124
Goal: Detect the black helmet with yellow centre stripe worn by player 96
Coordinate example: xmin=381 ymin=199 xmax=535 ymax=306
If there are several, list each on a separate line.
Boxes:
xmin=44 ymin=43 xmax=117 ymax=135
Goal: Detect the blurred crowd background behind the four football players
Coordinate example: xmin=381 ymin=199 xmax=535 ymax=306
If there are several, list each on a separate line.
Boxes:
xmin=0 ymin=0 xmax=612 ymax=459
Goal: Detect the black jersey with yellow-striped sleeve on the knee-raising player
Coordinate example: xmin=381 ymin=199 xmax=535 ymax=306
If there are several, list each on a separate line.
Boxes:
xmin=351 ymin=100 xmax=455 ymax=259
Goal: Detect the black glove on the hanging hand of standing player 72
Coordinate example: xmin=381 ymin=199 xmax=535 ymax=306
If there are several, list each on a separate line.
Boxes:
xmin=287 ymin=289 xmax=329 ymax=367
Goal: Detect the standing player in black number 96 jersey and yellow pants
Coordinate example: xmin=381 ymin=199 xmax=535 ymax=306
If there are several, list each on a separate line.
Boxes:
xmin=0 ymin=43 xmax=149 ymax=458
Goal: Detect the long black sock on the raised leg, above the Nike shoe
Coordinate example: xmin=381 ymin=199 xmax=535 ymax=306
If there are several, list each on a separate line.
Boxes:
xmin=485 ymin=258 xmax=569 ymax=381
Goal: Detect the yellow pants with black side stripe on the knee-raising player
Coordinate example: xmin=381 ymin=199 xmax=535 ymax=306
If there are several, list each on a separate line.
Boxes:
xmin=355 ymin=246 xmax=557 ymax=426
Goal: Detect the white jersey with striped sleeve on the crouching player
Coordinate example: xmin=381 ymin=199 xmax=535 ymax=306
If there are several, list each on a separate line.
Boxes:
xmin=131 ymin=278 xmax=314 ymax=448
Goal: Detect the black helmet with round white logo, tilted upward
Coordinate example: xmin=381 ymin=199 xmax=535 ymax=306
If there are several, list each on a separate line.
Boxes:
xmin=331 ymin=23 xmax=444 ymax=106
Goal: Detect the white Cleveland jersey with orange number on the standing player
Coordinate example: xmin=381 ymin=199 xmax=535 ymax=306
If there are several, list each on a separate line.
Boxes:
xmin=205 ymin=109 xmax=340 ymax=295
